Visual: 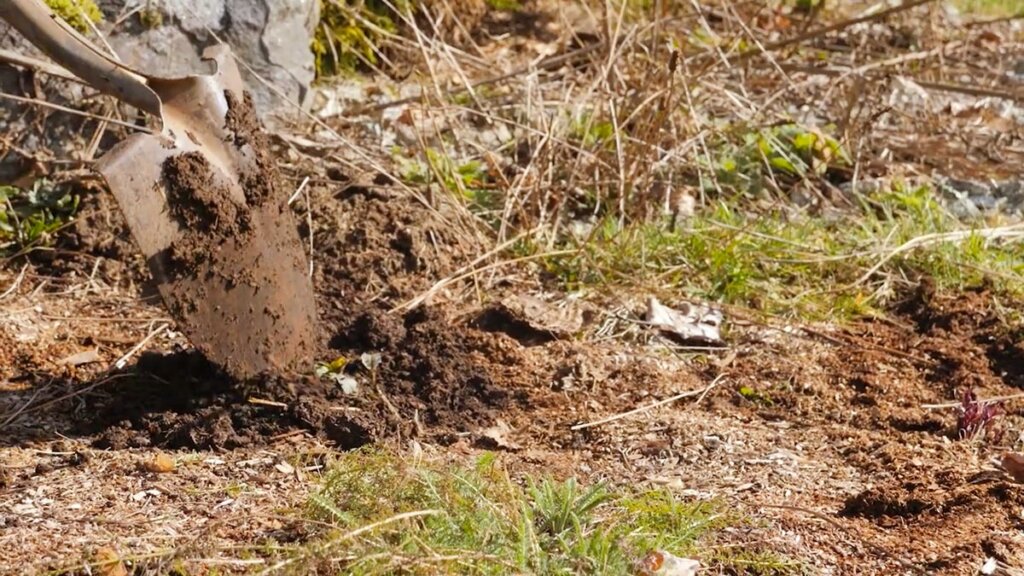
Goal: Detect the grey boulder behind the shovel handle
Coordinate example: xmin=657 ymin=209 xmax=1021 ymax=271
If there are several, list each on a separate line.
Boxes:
xmin=0 ymin=0 xmax=319 ymax=180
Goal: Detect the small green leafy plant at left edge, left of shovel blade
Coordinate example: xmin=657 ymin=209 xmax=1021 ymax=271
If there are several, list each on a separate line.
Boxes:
xmin=0 ymin=180 xmax=78 ymax=254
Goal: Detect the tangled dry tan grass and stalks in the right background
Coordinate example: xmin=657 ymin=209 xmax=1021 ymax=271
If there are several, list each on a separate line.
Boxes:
xmin=284 ymin=0 xmax=1024 ymax=318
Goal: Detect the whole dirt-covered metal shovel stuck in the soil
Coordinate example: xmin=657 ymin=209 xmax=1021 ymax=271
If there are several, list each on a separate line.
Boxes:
xmin=0 ymin=0 xmax=316 ymax=379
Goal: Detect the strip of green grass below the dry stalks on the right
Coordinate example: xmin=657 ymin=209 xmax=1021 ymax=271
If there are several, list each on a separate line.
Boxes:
xmin=536 ymin=181 xmax=1024 ymax=321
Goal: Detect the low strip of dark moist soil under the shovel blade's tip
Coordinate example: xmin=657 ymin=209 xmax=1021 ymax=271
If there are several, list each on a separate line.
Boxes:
xmin=81 ymin=303 xmax=525 ymax=449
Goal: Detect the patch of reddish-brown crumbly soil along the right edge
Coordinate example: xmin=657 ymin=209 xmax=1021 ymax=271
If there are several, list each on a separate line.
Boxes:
xmin=716 ymin=281 xmax=1024 ymax=574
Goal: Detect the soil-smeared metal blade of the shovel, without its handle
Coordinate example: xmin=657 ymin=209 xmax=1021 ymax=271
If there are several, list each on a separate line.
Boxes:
xmin=97 ymin=48 xmax=316 ymax=379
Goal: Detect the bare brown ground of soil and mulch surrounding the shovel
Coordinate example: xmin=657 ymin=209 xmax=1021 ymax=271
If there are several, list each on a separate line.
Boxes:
xmin=0 ymin=0 xmax=1024 ymax=575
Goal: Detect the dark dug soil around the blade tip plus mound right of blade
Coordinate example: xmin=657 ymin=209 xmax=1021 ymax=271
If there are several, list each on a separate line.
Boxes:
xmin=74 ymin=171 xmax=528 ymax=449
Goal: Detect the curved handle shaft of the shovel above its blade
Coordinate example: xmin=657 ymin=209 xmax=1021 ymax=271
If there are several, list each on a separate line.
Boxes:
xmin=0 ymin=0 xmax=162 ymax=118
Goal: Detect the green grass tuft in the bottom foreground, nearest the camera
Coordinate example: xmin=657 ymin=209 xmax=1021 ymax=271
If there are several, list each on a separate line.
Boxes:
xmin=276 ymin=450 xmax=800 ymax=575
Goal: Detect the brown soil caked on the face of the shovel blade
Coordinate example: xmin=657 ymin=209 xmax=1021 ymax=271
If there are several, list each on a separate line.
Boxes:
xmin=152 ymin=92 xmax=316 ymax=377
